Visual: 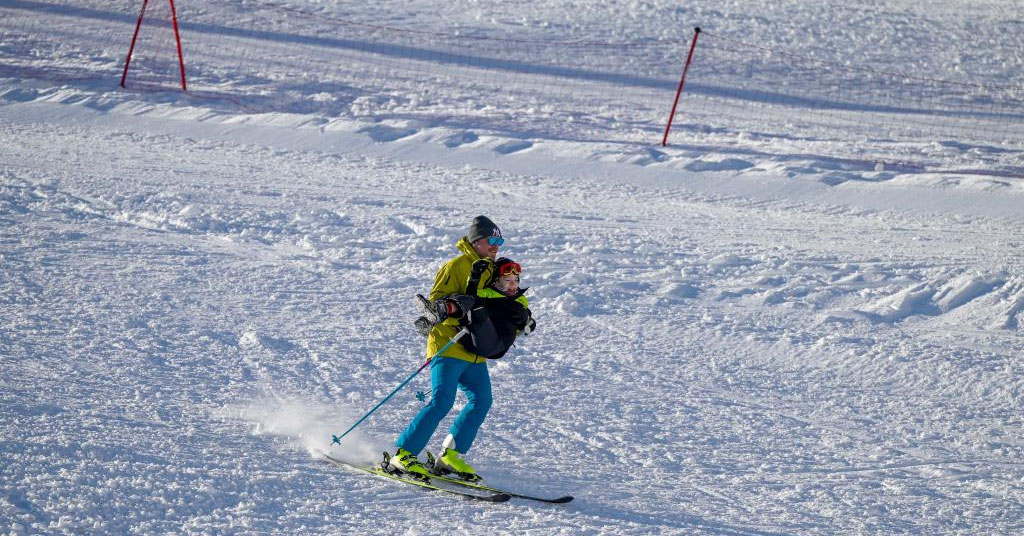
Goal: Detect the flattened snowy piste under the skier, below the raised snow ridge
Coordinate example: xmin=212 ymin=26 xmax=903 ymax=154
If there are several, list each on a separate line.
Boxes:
xmin=2 ymin=104 xmax=1021 ymax=534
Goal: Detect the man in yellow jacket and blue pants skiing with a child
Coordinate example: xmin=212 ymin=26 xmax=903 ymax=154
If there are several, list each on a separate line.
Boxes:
xmin=389 ymin=216 xmax=536 ymax=480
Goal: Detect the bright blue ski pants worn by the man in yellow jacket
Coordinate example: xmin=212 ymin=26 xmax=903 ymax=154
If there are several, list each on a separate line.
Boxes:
xmin=395 ymin=357 xmax=492 ymax=455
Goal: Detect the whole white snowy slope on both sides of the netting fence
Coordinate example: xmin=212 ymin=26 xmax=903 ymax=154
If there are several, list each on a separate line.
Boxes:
xmin=0 ymin=0 xmax=1024 ymax=535
